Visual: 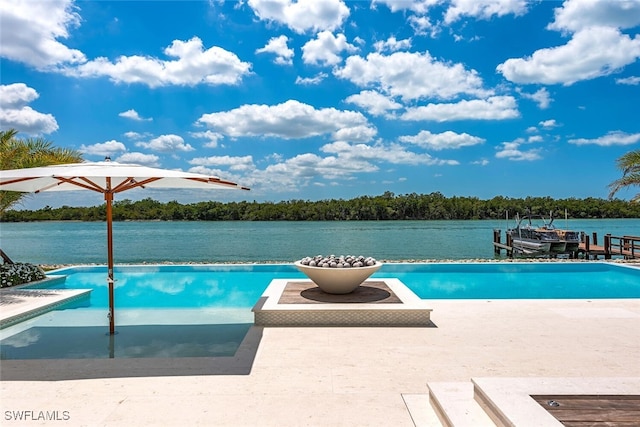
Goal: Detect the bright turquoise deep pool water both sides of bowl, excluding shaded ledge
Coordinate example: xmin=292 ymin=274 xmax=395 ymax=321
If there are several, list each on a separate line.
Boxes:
xmin=45 ymin=262 xmax=640 ymax=302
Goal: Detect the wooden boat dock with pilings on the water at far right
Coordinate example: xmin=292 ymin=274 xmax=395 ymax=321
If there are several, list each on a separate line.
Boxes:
xmin=493 ymin=229 xmax=640 ymax=260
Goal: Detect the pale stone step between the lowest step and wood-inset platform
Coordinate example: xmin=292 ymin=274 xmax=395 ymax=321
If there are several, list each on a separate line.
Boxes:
xmin=427 ymin=381 xmax=496 ymax=427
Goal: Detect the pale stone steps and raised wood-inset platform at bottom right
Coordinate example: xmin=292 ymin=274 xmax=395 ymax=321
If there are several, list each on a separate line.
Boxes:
xmin=424 ymin=377 xmax=640 ymax=427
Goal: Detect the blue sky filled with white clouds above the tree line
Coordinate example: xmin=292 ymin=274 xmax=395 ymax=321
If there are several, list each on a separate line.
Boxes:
xmin=0 ymin=0 xmax=640 ymax=209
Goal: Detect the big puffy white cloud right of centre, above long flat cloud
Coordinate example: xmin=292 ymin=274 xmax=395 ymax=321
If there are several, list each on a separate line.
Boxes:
xmin=334 ymin=52 xmax=491 ymax=101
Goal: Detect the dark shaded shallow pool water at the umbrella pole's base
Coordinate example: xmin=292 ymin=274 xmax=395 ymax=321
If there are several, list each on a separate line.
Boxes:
xmin=0 ymin=323 xmax=252 ymax=360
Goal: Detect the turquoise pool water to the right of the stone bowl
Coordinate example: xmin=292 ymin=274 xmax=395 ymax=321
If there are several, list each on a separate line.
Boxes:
xmin=382 ymin=263 xmax=640 ymax=299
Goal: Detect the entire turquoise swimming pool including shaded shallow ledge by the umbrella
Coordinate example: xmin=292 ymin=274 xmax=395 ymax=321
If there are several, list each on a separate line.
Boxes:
xmin=0 ymin=262 xmax=640 ymax=359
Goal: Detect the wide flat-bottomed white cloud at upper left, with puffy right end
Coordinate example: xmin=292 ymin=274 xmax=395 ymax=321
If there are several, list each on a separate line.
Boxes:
xmin=66 ymin=37 xmax=251 ymax=88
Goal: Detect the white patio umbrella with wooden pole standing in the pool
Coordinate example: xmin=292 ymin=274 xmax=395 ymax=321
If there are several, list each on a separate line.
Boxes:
xmin=0 ymin=158 xmax=248 ymax=335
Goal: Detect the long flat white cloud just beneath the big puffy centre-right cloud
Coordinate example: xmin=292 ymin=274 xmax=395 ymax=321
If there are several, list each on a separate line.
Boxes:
xmin=400 ymin=96 xmax=520 ymax=122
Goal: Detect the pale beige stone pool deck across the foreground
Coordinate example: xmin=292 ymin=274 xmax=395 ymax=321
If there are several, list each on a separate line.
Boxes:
xmin=0 ymin=299 xmax=640 ymax=426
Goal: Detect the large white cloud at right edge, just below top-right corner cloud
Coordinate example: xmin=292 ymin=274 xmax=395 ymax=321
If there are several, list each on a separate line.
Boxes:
xmin=497 ymin=27 xmax=640 ymax=86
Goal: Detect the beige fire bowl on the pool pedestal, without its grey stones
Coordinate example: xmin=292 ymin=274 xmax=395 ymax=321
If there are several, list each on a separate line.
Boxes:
xmin=294 ymin=261 xmax=382 ymax=294
